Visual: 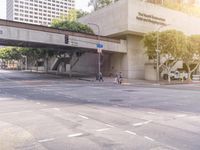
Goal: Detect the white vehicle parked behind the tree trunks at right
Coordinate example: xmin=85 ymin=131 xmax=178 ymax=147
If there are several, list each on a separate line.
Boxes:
xmin=163 ymin=71 xmax=188 ymax=80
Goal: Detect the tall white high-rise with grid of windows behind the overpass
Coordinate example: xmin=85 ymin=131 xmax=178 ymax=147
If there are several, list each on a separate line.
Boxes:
xmin=7 ymin=0 xmax=75 ymax=26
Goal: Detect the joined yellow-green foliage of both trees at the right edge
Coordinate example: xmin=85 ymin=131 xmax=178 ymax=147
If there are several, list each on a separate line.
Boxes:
xmin=143 ymin=30 xmax=200 ymax=80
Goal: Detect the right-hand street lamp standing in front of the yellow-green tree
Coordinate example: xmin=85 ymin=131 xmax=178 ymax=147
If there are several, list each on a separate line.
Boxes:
xmin=156 ymin=24 xmax=170 ymax=83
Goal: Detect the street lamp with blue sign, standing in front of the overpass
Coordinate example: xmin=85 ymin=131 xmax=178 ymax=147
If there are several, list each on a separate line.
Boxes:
xmin=88 ymin=23 xmax=102 ymax=77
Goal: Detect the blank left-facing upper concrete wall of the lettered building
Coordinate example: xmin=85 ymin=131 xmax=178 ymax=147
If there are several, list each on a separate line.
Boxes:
xmin=79 ymin=0 xmax=128 ymax=36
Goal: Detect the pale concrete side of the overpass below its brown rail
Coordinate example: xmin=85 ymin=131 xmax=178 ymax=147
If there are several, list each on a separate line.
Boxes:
xmin=0 ymin=26 xmax=127 ymax=53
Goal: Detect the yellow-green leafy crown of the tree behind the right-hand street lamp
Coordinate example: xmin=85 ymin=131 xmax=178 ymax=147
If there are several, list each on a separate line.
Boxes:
xmin=143 ymin=30 xmax=187 ymax=59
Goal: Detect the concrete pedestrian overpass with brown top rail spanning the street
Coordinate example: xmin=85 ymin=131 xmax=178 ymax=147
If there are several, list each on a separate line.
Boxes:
xmin=0 ymin=19 xmax=127 ymax=53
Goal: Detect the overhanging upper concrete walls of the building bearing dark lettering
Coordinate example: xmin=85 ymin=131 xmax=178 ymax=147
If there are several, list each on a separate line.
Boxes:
xmin=79 ymin=0 xmax=200 ymax=37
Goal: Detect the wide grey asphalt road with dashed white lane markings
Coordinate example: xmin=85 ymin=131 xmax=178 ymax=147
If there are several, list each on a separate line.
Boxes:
xmin=0 ymin=70 xmax=200 ymax=150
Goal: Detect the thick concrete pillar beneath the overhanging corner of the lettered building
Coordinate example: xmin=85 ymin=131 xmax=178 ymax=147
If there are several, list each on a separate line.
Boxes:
xmin=110 ymin=35 xmax=147 ymax=79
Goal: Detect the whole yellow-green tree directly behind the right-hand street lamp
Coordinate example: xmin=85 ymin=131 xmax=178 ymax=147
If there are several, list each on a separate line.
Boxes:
xmin=143 ymin=30 xmax=187 ymax=82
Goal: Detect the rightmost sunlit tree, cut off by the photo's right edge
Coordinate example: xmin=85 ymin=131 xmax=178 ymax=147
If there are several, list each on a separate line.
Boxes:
xmin=182 ymin=35 xmax=200 ymax=81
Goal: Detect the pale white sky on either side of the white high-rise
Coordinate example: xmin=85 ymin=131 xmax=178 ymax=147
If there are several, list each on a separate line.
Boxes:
xmin=0 ymin=0 xmax=90 ymax=19
